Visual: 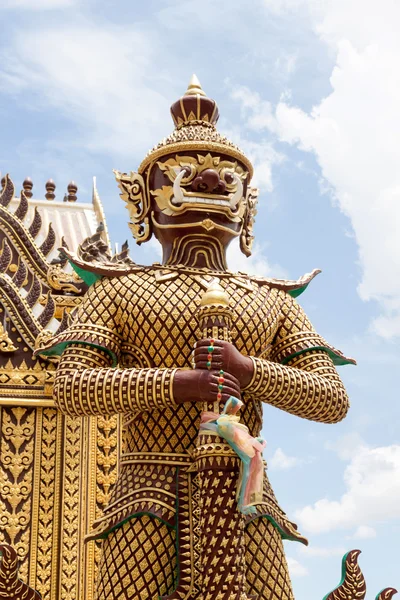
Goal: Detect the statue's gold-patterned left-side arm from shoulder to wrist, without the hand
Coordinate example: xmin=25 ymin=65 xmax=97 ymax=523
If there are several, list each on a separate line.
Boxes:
xmin=48 ymin=278 xmax=175 ymax=416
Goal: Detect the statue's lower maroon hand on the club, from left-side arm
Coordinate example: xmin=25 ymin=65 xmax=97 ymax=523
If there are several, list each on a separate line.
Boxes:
xmin=172 ymin=369 xmax=240 ymax=404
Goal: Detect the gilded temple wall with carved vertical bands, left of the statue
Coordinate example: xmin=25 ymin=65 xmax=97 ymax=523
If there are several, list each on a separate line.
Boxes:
xmin=0 ymin=398 xmax=118 ymax=600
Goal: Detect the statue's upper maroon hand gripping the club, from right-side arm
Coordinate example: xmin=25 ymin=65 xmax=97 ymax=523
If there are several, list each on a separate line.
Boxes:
xmin=194 ymin=340 xmax=254 ymax=388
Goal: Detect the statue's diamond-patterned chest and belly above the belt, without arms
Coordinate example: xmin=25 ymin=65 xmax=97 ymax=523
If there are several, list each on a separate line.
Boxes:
xmin=113 ymin=271 xmax=285 ymax=452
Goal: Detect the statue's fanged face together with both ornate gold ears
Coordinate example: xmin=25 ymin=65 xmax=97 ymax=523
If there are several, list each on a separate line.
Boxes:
xmin=115 ymin=151 xmax=258 ymax=256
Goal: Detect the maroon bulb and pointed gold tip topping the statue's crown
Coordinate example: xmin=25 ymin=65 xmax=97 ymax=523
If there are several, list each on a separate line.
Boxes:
xmin=171 ymin=75 xmax=219 ymax=129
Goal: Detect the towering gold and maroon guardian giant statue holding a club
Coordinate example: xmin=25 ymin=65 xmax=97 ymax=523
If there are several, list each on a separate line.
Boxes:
xmin=40 ymin=76 xmax=353 ymax=600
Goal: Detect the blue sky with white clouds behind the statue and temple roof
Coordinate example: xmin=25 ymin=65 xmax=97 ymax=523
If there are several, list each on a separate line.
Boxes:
xmin=0 ymin=0 xmax=400 ymax=600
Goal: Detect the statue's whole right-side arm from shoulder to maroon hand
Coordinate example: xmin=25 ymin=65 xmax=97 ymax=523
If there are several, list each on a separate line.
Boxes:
xmin=195 ymin=292 xmax=354 ymax=423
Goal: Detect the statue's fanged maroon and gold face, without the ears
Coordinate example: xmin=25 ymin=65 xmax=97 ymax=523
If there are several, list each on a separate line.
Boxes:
xmin=148 ymin=152 xmax=249 ymax=232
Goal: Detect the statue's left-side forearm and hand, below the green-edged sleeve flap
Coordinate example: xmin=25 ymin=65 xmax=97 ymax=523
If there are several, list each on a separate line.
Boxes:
xmin=53 ymin=343 xmax=240 ymax=416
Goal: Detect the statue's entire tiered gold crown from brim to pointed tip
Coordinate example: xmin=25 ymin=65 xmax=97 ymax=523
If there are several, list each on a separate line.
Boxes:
xmin=138 ymin=75 xmax=253 ymax=178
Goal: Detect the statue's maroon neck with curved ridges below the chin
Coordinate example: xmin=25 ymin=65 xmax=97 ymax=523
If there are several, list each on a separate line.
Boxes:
xmin=163 ymin=234 xmax=228 ymax=271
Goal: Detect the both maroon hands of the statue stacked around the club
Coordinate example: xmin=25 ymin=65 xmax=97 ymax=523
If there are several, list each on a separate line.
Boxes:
xmin=173 ymin=340 xmax=253 ymax=404
